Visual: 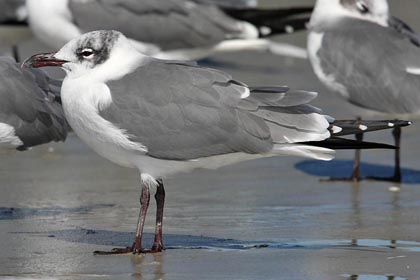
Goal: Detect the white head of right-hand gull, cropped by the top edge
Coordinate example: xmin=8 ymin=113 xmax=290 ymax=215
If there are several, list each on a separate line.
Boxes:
xmin=310 ymin=0 xmax=389 ymax=27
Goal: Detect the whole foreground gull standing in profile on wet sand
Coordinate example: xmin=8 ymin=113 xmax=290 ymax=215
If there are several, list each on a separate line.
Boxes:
xmin=24 ymin=31 xmax=406 ymax=253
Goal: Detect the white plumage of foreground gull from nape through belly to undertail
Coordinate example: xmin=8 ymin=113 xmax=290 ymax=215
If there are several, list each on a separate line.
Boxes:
xmin=55 ymin=34 xmax=333 ymax=178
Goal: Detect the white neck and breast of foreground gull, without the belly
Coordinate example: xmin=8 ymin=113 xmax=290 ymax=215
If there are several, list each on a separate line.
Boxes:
xmin=61 ymin=48 xmax=149 ymax=167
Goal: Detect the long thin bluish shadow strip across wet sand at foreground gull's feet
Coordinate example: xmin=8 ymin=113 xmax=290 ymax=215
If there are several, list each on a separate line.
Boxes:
xmin=13 ymin=229 xmax=420 ymax=252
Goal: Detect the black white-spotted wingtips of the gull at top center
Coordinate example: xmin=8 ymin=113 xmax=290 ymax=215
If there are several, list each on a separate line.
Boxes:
xmin=223 ymin=7 xmax=313 ymax=35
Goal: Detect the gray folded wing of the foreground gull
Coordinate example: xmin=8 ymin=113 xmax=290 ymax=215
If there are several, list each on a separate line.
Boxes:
xmin=100 ymin=60 xmax=329 ymax=160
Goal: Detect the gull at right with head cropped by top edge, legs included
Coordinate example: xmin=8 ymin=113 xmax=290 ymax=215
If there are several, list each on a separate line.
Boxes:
xmin=308 ymin=0 xmax=420 ymax=182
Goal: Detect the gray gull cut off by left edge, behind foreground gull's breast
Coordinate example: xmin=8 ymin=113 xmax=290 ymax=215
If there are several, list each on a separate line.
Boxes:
xmin=0 ymin=57 xmax=69 ymax=150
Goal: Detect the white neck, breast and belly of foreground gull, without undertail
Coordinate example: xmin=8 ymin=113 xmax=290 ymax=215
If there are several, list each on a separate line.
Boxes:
xmin=58 ymin=40 xmax=262 ymax=178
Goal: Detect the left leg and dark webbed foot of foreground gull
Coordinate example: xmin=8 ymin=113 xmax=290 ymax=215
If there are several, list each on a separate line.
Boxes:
xmin=94 ymin=182 xmax=151 ymax=255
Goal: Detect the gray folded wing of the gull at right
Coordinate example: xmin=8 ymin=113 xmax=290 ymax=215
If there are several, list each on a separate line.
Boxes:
xmin=318 ymin=19 xmax=420 ymax=114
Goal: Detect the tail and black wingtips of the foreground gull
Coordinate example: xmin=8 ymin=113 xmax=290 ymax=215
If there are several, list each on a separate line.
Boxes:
xmin=243 ymin=86 xmax=411 ymax=160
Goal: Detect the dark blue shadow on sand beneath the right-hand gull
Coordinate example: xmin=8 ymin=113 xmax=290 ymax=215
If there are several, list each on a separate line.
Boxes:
xmin=295 ymin=160 xmax=420 ymax=184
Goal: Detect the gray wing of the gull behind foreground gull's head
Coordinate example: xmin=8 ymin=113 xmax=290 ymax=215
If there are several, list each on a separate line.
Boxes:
xmin=69 ymin=0 xmax=244 ymax=50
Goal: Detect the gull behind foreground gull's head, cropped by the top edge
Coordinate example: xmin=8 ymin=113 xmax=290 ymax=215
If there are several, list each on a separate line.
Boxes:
xmin=27 ymin=0 xmax=309 ymax=60
